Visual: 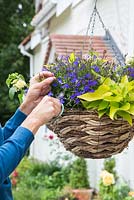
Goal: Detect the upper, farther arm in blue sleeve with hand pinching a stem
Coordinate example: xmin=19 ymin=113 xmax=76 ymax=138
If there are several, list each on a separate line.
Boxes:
xmin=3 ymin=72 xmax=55 ymax=140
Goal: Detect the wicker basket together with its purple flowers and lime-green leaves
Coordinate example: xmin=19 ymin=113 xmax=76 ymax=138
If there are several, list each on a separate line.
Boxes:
xmin=43 ymin=52 xmax=134 ymax=158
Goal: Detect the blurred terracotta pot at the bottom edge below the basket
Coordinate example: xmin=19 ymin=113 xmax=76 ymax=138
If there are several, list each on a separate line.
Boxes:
xmin=72 ymin=189 xmax=93 ymax=200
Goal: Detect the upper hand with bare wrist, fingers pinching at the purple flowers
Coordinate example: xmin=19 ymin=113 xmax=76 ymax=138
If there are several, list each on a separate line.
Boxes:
xmin=20 ymin=71 xmax=56 ymax=115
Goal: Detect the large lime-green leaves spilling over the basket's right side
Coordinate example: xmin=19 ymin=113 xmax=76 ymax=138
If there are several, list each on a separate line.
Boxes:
xmin=79 ymin=76 xmax=134 ymax=125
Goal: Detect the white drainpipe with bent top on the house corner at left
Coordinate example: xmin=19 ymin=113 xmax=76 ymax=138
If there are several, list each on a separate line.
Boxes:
xmin=19 ymin=44 xmax=34 ymax=78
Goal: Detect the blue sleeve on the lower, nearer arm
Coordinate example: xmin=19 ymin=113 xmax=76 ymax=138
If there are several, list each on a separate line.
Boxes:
xmin=0 ymin=126 xmax=34 ymax=184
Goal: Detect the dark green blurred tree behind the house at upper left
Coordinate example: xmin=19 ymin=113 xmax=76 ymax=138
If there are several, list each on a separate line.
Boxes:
xmin=0 ymin=0 xmax=34 ymax=124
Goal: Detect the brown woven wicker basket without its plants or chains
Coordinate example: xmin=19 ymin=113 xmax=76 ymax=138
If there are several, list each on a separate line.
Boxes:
xmin=48 ymin=110 xmax=134 ymax=159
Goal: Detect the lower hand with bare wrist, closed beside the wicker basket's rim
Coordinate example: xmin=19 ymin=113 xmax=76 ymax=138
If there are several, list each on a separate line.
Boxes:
xmin=21 ymin=96 xmax=62 ymax=134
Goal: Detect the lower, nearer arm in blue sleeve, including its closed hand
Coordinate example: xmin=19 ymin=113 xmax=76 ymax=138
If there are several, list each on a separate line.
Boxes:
xmin=0 ymin=96 xmax=61 ymax=184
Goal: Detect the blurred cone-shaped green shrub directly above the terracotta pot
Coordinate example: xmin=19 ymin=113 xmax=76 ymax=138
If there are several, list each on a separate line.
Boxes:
xmin=70 ymin=158 xmax=89 ymax=189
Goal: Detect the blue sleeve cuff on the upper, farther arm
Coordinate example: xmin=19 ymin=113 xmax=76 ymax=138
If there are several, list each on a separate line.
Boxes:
xmin=2 ymin=109 xmax=27 ymax=140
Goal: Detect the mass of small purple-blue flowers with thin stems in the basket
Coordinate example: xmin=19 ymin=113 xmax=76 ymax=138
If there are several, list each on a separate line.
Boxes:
xmin=44 ymin=51 xmax=115 ymax=109
